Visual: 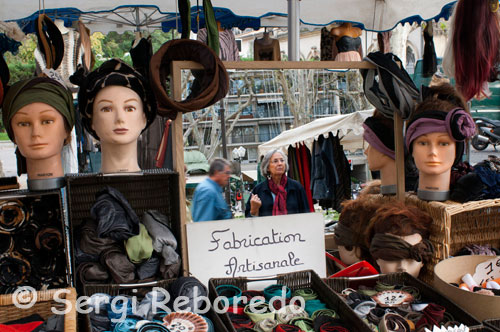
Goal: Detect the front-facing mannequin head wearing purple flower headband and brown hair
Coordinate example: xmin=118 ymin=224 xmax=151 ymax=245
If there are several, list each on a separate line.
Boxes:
xmin=406 ymin=84 xmax=475 ymax=196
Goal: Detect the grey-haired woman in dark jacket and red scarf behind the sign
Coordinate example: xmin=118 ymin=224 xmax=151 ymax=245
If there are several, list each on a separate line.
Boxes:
xmin=245 ymin=150 xmax=310 ymax=217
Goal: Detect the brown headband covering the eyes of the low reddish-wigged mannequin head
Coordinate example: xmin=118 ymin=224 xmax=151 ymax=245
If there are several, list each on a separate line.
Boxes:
xmin=370 ymin=233 xmax=434 ymax=262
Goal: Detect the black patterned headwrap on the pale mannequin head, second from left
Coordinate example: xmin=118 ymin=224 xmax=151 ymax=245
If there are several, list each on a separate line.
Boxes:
xmin=70 ymin=59 xmax=156 ymax=139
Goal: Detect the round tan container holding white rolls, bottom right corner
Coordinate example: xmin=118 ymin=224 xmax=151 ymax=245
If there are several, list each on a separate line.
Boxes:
xmin=434 ymin=256 xmax=500 ymax=321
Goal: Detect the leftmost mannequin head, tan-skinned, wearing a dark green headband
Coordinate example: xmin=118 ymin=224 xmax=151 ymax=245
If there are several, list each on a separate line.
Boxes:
xmin=2 ymin=77 xmax=75 ymax=180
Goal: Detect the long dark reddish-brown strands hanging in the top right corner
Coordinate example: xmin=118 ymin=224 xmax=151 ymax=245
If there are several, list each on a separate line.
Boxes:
xmin=452 ymin=0 xmax=500 ymax=100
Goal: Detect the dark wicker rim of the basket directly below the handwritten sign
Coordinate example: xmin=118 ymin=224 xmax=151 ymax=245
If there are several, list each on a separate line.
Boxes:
xmin=208 ymin=270 xmax=371 ymax=332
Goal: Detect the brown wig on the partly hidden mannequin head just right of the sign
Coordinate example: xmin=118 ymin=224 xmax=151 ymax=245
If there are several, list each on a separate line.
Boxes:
xmin=339 ymin=195 xmax=380 ymax=263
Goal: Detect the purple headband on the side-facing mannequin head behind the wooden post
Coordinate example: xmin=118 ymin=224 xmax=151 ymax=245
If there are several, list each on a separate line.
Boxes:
xmin=363 ymin=117 xmax=396 ymax=159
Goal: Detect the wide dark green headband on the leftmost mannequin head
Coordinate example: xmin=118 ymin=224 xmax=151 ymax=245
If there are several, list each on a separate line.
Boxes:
xmin=2 ymin=77 xmax=75 ymax=141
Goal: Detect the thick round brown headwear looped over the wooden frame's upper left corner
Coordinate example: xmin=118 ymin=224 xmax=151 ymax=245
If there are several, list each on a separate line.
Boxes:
xmin=150 ymin=39 xmax=229 ymax=119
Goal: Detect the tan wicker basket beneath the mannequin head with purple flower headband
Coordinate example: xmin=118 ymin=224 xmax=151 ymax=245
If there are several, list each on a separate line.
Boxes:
xmin=366 ymin=194 xmax=500 ymax=284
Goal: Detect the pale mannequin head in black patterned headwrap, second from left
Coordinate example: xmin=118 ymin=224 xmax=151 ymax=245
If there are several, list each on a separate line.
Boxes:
xmin=70 ymin=59 xmax=156 ymax=173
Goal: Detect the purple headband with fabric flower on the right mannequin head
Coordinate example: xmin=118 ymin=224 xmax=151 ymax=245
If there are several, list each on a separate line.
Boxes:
xmin=406 ymin=108 xmax=476 ymax=149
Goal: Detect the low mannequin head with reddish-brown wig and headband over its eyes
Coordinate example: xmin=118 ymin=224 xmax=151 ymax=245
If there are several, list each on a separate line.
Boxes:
xmin=368 ymin=202 xmax=433 ymax=277
